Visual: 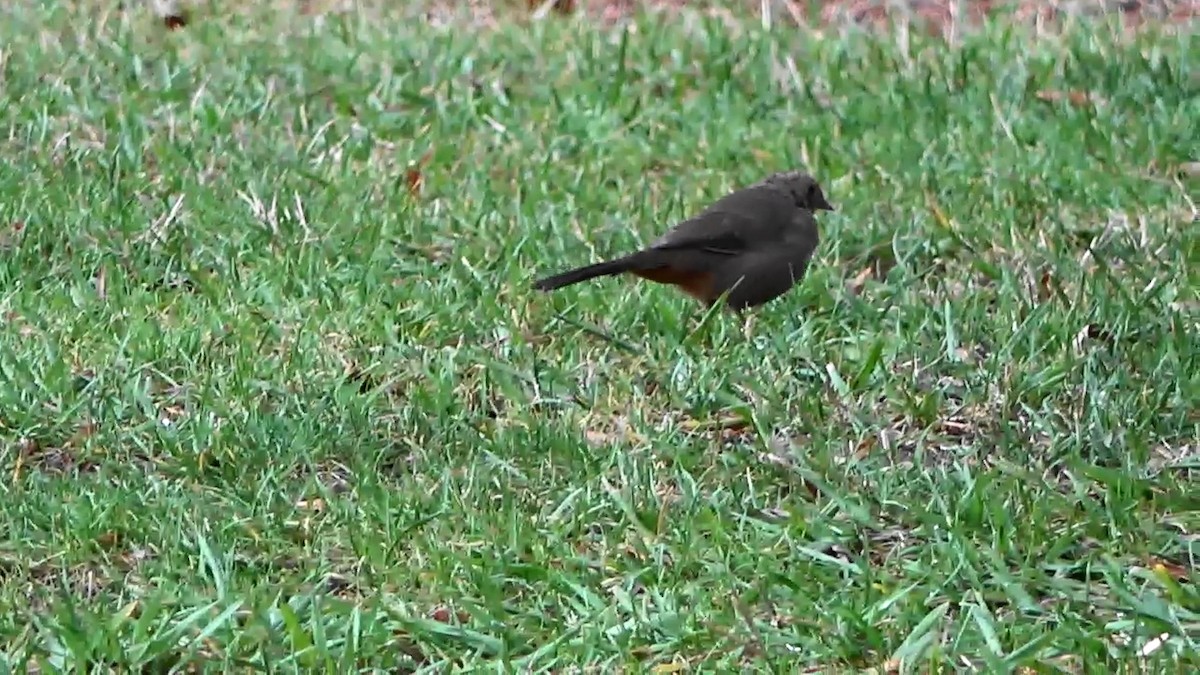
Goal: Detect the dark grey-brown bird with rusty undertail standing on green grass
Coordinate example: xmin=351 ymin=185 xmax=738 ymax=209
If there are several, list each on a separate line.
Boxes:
xmin=533 ymin=171 xmax=833 ymax=311
